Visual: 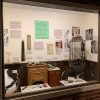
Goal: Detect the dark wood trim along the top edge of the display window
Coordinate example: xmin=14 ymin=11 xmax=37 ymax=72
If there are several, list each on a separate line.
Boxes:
xmin=3 ymin=0 xmax=100 ymax=13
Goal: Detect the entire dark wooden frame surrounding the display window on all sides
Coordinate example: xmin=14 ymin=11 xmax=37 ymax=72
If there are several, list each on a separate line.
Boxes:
xmin=0 ymin=0 xmax=100 ymax=100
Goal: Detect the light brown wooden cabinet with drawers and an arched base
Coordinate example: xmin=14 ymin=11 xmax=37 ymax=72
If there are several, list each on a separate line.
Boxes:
xmin=27 ymin=64 xmax=48 ymax=85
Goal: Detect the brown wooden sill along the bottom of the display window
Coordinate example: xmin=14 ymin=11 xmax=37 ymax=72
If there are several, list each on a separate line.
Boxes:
xmin=5 ymin=82 xmax=100 ymax=100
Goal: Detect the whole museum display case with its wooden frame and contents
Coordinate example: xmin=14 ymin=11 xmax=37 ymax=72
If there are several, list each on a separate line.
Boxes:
xmin=2 ymin=0 xmax=100 ymax=100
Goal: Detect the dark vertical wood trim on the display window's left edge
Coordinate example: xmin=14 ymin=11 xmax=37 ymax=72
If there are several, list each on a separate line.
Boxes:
xmin=0 ymin=0 xmax=4 ymax=100
